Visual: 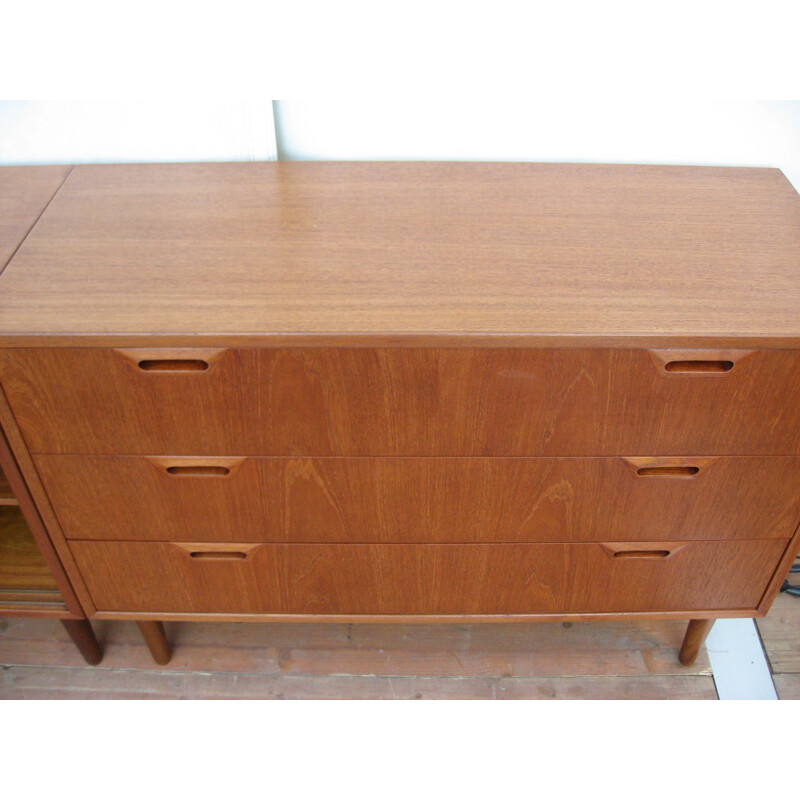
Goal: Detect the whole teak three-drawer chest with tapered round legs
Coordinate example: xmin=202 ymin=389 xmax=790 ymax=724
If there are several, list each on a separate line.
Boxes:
xmin=0 ymin=163 xmax=800 ymax=663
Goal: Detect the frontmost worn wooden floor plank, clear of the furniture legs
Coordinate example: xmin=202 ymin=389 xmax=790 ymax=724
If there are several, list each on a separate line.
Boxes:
xmin=0 ymin=667 xmax=716 ymax=700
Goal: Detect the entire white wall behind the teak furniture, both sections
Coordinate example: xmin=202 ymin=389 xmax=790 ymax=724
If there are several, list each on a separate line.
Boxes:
xmin=0 ymin=98 xmax=800 ymax=192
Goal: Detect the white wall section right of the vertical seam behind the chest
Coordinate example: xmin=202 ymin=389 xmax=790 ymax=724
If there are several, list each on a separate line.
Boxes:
xmin=275 ymin=97 xmax=800 ymax=186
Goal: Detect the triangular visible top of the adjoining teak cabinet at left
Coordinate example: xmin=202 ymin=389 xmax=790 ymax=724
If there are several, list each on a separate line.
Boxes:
xmin=0 ymin=165 xmax=72 ymax=276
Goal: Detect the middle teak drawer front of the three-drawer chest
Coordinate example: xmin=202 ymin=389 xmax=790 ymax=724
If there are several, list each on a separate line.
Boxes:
xmin=35 ymin=455 xmax=800 ymax=543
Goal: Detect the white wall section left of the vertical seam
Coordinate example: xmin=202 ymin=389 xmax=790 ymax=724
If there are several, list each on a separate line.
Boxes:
xmin=0 ymin=100 xmax=276 ymax=164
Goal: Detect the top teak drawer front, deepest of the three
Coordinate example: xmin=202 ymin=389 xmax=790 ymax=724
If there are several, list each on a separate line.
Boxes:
xmin=0 ymin=347 xmax=800 ymax=456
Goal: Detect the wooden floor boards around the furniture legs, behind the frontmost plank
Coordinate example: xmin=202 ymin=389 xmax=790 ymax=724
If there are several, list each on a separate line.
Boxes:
xmin=0 ymin=619 xmax=710 ymax=677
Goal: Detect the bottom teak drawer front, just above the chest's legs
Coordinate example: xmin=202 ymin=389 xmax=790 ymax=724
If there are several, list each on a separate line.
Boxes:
xmin=70 ymin=540 xmax=786 ymax=614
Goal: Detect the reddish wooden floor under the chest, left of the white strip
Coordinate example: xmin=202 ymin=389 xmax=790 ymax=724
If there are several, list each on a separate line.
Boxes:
xmin=0 ymin=616 xmax=712 ymax=699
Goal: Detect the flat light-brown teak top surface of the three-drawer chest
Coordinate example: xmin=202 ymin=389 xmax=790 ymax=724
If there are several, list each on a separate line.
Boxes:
xmin=0 ymin=163 xmax=800 ymax=344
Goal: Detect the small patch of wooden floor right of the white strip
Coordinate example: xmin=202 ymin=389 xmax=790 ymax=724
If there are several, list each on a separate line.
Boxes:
xmin=757 ymin=588 xmax=800 ymax=700
